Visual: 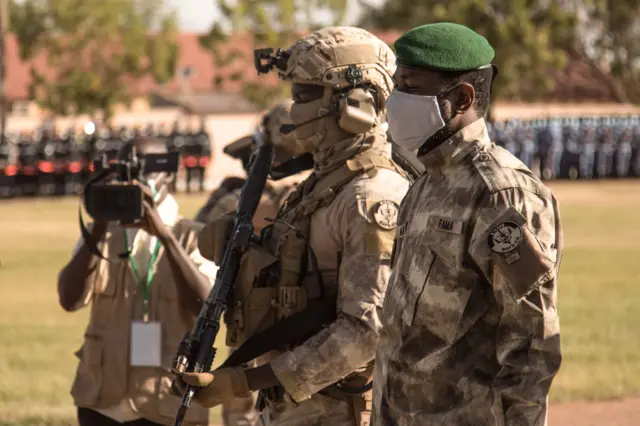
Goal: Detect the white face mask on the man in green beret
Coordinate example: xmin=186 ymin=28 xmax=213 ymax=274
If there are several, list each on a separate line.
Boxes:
xmin=386 ymin=90 xmax=445 ymax=151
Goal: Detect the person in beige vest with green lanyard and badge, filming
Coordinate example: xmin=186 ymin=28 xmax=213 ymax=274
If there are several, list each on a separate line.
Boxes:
xmin=58 ymin=138 xmax=216 ymax=426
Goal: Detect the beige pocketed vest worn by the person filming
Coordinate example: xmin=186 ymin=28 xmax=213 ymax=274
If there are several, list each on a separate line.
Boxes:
xmin=71 ymin=219 xmax=209 ymax=426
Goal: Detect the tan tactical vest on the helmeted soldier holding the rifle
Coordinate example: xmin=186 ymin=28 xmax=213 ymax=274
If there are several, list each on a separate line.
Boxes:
xmin=225 ymin=151 xmax=404 ymax=348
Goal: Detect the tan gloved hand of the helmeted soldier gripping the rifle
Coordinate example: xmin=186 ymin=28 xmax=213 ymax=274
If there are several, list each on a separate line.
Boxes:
xmin=171 ymin=367 xmax=251 ymax=408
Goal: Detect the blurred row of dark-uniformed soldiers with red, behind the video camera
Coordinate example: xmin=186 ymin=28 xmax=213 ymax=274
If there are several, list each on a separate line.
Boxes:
xmin=0 ymin=122 xmax=211 ymax=198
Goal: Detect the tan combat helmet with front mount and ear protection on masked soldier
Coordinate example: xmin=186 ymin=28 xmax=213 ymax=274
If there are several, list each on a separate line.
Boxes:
xmin=255 ymin=27 xmax=396 ymax=151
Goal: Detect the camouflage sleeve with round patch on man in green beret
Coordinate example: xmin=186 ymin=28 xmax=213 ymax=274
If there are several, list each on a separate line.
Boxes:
xmin=470 ymin=188 xmax=562 ymax=426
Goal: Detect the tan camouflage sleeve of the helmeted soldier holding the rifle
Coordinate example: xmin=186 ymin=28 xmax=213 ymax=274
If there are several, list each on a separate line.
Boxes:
xmin=271 ymin=171 xmax=407 ymax=402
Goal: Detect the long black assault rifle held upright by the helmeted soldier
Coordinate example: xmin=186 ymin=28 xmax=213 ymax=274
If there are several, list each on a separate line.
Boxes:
xmin=173 ymin=128 xmax=273 ymax=426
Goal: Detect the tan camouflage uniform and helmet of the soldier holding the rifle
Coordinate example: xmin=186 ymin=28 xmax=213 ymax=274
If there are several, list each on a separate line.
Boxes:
xmin=214 ymin=27 xmax=409 ymax=426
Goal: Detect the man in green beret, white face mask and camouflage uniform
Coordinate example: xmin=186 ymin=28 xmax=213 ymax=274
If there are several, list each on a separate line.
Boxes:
xmin=372 ymin=23 xmax=563 ymax=426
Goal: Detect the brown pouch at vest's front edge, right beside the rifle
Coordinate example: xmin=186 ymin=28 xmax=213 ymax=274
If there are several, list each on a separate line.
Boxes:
xmin=225 ymin=246 xmax=278 ymax=348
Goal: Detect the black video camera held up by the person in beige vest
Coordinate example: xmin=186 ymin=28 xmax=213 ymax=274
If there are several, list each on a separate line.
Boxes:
xmin=84 ymin=148 xmax=180 ymax=224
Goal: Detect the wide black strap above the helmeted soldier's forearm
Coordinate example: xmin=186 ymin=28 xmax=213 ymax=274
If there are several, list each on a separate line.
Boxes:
xmin=219 ymin=298 xmax=336 ymax=368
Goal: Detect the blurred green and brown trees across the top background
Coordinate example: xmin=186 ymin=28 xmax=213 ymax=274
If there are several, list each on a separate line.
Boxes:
xmin=9 ymin=0 xmax=640 ymax=117
